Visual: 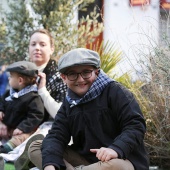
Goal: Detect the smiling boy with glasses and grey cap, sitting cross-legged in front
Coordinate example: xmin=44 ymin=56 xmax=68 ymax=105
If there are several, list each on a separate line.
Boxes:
xmin=29 ymin=48 xmax=149 ymax=170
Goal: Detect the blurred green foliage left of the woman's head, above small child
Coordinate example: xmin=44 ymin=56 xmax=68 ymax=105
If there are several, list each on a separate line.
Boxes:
xmin=0 ymin=0 xmax=33 ymax=63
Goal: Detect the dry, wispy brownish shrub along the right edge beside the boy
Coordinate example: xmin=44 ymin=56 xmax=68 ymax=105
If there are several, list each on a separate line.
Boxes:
xmin=131 ymin=47 xmax=170 ymax=168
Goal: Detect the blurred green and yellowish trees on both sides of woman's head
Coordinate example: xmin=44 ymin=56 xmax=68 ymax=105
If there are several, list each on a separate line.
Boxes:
xmin=0 ymin=0 xmax=103 ymax=63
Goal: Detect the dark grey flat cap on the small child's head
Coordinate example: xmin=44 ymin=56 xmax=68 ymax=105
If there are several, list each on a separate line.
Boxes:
xmin=6 ymin=61 xmax=38 ymax=77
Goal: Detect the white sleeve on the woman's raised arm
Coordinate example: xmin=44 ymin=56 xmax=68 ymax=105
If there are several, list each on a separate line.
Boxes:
xmin=38 ymin=87 xmax=62 ymax=118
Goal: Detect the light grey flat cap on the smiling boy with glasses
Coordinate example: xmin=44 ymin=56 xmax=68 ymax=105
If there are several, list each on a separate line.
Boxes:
xmin=58 ymin=48 xmax=100 ymax=73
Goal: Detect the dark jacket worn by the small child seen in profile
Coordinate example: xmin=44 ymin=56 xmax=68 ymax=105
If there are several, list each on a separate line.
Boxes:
xmin=0 ymin=91 xmax=44 ymax=133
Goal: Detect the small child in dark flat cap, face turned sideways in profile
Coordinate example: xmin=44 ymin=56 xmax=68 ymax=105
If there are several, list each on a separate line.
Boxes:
xmin=0 ymin=61 xmax=44 ymax=153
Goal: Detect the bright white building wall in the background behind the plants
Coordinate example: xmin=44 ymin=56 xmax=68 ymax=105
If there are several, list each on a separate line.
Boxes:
xmin=103 ymin=0 xmax=160 ymax=79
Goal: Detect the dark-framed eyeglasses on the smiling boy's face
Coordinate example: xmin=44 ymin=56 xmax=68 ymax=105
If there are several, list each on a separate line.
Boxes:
xmin=66 ymin=70 xmax=94 ymax=81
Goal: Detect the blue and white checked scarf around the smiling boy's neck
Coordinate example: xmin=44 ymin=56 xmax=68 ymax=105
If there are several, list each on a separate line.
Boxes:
xmin=66 ymin=70 xmax=114 ymax=107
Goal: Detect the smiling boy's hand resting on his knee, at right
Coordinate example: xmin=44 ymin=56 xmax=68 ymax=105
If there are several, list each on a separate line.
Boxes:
xmin=90 ymin=147 xmax=118 ymax=162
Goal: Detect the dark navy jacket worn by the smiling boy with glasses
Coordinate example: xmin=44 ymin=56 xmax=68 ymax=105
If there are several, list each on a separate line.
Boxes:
xmin=42 ymin=82 xmax=149 ymax=170
